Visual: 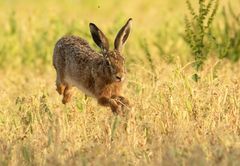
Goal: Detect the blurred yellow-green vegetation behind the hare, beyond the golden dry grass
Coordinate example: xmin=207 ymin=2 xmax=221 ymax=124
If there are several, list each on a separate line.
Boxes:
xmin=0 ymin=0 xmax=240 ymax=69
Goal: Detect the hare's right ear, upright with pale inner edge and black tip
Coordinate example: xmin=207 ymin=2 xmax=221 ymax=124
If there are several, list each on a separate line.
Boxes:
xmin=114 ymin=18 xmax=132 ymax=52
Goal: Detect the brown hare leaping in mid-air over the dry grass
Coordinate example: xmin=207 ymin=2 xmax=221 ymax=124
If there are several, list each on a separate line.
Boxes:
xmin=53 ymin=18 xmax=132 ymax=113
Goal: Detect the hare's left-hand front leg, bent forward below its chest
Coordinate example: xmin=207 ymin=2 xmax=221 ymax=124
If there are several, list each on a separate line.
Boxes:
xmin=98 ymin=97 xmax=120 ymax=114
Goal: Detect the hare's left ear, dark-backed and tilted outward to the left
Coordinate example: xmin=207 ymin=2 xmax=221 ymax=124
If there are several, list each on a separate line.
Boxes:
xmin=89 ymin=23 xmax=109 ymax=51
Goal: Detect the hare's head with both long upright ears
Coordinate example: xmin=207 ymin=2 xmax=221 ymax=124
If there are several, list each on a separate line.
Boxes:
xmin=89 ymin=18 xmax=132 ymax=82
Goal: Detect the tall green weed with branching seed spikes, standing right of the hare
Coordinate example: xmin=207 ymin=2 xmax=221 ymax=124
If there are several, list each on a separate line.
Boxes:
xmin=184 ymin=0 xmax=218 ymax=81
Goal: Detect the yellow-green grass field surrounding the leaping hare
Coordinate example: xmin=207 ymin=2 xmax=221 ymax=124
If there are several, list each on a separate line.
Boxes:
xmin=0 ymin=0 xmax=240 ymax=165
